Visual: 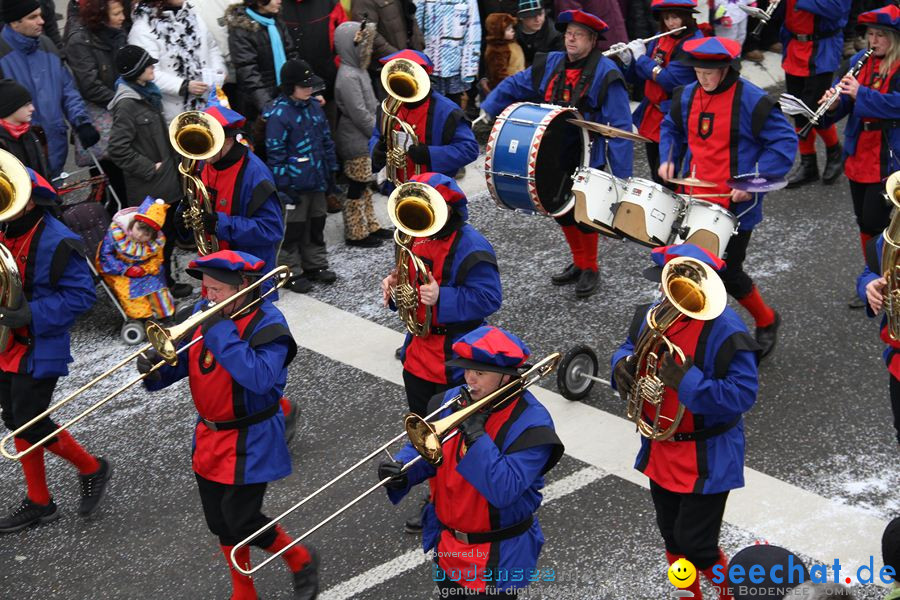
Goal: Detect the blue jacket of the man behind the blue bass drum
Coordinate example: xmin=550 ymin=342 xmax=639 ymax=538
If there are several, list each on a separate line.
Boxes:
xmin=481 ymin=52 xmax=634 ymax=178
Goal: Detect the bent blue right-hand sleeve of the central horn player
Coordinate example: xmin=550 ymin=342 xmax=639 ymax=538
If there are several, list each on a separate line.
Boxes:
xmin=437 ymin=261 xmax=503 ymax=323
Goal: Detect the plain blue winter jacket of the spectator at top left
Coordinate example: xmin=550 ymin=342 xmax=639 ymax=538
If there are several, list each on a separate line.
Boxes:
xmin=0 ymin=27 xmax=91 ymax=177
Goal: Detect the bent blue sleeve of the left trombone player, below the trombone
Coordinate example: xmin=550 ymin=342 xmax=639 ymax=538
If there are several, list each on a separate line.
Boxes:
xmin=203 ymin=319 xmax=289 ymax=394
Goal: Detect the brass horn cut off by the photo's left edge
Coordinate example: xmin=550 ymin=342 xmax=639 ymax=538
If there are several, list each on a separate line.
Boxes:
xmin=0 ymin=150 xmax=31 ymax=351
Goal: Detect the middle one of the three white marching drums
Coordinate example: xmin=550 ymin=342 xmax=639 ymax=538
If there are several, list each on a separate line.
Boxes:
xmin=613 ymin=177 xmax=685 ymax=248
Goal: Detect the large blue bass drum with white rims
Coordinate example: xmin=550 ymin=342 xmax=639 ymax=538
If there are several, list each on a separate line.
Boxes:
xmin=484 ymin=102 xmax=590 ymax=217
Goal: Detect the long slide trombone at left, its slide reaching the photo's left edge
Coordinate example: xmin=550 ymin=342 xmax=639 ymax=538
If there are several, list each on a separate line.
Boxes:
xmin=0 ymin=266 xmax=290 ymax=460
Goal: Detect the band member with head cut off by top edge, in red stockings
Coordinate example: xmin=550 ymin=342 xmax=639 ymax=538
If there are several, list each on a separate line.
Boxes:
xmin=776 ymin=0 xmax=851 ymax=187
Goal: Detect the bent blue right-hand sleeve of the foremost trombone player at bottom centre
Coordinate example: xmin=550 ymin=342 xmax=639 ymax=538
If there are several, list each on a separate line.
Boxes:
xmin=456 ymin=435 xmax=552 ymax=508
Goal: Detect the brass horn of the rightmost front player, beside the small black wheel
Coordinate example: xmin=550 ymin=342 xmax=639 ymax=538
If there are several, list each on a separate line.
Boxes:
xmin=623 ymin=256 xmax=727 ymax=441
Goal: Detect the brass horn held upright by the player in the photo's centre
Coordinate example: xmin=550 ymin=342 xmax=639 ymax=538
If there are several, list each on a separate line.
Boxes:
xmin=388 ymin=181 xmax=448 ymax=337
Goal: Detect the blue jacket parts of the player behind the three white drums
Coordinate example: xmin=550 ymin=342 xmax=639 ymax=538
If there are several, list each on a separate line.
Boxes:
xmin=659 ymin=77 xmax=797 ymax=231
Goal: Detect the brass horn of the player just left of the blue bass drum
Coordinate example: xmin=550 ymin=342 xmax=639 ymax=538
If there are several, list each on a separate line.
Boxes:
xmin=379 ymin=58 xmax=431 ymax=185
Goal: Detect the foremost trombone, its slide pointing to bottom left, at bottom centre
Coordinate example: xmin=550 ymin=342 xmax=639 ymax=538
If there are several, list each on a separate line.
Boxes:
xmin=229 ymin=352 xmax=562 ymax=575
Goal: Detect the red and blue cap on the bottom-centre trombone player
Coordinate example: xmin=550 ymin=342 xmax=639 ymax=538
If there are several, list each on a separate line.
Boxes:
xmin=446 ymin=325 xmax=531 ymax=375
